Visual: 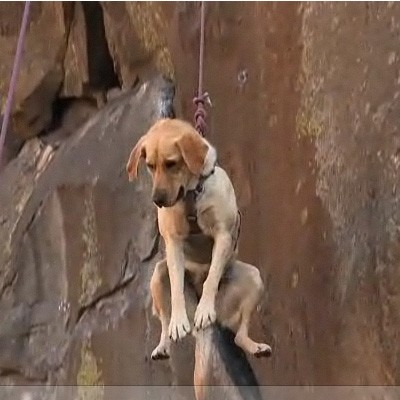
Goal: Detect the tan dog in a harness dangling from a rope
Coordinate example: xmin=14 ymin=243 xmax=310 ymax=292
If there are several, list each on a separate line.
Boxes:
xmin=127 ymin=119 xmax=271 ymax=359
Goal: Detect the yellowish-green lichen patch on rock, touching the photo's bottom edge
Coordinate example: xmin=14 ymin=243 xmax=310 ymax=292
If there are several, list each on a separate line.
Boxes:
xmin=76 ymin=340 xmax=104 ymax=400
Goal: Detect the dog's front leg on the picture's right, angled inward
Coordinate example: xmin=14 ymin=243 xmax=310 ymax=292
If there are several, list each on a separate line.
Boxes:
xmin=194 ymin=231 xmax=233 ymax=329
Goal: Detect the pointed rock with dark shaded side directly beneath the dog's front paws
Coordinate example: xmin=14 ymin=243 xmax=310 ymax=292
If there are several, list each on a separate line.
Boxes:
xmin=195 ymin=324 xmax=262 ymax=400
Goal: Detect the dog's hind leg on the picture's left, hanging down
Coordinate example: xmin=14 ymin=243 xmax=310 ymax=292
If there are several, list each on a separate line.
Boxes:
xmin=150 ymin=259 xmax=171 ymax=360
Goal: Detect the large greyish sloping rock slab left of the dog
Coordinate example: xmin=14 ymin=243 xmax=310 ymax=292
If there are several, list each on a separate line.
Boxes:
xmin=0 ymin=74 xmax=178 ymax=384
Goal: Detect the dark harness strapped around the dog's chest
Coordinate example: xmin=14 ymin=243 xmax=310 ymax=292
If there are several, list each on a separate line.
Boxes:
xmin=184 ymin=167 xmax=242 ymax=250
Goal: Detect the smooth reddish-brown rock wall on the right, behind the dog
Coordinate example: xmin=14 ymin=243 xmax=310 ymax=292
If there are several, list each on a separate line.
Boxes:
xmin=161 ymin=2 xmax=400 ymax=386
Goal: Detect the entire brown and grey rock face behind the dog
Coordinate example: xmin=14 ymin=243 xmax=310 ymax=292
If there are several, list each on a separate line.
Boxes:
xmin=0 ymin=2 xmax=400 ymax=390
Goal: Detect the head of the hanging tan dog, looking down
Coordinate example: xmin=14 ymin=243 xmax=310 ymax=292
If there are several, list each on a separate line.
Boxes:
xmin=126 ymin=119 xmax=216 ymax=207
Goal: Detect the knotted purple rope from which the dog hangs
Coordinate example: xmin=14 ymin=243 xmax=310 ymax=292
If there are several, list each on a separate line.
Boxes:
xmin=193 ymin=1 xmax=210 ymax=137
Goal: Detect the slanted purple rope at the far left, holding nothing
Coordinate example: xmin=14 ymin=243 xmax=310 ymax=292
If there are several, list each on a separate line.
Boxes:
xmin=0 ymin=1 xmax=31 ymax=166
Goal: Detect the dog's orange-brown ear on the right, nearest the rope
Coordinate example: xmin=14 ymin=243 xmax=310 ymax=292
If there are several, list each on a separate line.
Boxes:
xmin=176 ymin=133 xmax=208 ymax=175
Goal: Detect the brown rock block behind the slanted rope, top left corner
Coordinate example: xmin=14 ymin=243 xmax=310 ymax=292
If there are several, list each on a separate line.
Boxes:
xmin=0 ymin=2 xmax=70 ymax=139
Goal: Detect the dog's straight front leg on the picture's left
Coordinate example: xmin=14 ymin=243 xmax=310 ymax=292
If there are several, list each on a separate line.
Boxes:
xmin=165 ymin=239 xmax=190 ymax=341
